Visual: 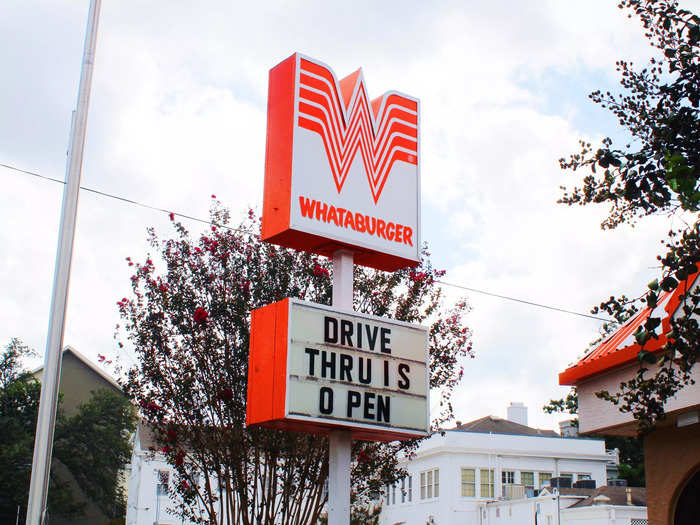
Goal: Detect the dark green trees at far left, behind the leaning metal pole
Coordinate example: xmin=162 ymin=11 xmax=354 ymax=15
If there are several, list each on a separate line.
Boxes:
xmin=0 ymin=339 xmax=136 ymax=523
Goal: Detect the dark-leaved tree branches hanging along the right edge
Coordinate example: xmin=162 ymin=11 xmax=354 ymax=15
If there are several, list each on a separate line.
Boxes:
xmin=560 ymin=0 xmax=700 ymax=432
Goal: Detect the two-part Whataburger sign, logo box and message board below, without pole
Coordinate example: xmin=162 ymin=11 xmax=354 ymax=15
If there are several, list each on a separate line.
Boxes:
xmin=246 ymin=53 xmax=429 ymax=441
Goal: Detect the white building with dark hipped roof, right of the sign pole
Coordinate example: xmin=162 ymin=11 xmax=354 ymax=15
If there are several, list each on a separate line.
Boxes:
xmin=380 ymin=405 xmax=629 ymax=525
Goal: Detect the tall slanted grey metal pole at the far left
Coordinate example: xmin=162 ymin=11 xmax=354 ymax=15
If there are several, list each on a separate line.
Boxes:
xmin=26 ymin=0 xmax=101 ymax=525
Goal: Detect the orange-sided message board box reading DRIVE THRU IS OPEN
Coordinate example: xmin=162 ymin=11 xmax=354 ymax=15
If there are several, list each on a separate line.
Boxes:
xmin=246 ymin=299 xmax=429 ymax=441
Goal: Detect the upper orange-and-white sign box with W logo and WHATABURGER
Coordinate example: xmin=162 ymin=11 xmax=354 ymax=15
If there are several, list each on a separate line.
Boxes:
xmin=262 ymin=53 xmax=421 ymax=271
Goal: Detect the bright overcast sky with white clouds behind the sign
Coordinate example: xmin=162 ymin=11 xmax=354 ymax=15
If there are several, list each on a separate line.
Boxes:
xmin=0 ymin=0 xmax=680 ymax=428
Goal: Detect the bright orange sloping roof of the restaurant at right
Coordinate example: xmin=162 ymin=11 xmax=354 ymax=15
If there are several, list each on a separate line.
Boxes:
xmin=559 ymin=273 xmax=700 ymax=385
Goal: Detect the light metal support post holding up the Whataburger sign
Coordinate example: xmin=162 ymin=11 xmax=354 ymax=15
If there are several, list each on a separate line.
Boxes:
xmin=328 ymin=250 xmax=354 ymax=525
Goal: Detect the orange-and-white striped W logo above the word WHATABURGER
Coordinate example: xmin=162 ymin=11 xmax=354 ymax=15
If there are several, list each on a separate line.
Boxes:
xmin=298 ymin=58 xmax=418 ymax=204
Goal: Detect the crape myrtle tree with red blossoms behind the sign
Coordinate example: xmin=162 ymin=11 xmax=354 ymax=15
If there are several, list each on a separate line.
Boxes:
xmin=117 ymin=201 xmax=473 ymax=524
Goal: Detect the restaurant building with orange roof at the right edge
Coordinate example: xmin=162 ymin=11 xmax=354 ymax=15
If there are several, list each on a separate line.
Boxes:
xmin=559 ymin=273 xmax=700 ymax=525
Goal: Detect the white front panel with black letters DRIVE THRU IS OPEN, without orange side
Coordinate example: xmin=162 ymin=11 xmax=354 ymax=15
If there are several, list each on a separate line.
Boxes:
xmin=286 ymin=301 xmax=429 ymax=435
